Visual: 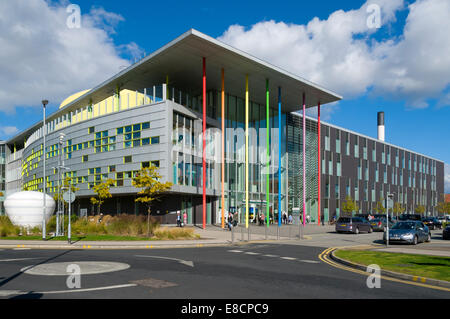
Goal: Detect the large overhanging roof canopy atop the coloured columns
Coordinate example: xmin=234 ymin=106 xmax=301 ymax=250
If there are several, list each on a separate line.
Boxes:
xmin=59 ymin=29 xmax=342 ymax=116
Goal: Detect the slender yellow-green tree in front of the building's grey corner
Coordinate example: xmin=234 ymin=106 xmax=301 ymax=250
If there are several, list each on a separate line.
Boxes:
xmin=132 ymin=165 xmax=173 ymax=237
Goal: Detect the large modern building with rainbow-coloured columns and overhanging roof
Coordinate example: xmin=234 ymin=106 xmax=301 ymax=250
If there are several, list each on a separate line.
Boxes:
xmin=0 ymin=30 xmax=444 ymax=225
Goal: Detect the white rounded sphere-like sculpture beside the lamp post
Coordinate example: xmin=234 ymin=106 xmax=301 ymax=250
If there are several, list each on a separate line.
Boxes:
xmin=4 ymin=192 xmax=55 ymax=228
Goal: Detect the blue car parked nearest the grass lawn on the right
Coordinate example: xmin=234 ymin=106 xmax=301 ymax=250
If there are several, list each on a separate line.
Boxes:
xmin=383 ymin=220 xmax=431 ymax=245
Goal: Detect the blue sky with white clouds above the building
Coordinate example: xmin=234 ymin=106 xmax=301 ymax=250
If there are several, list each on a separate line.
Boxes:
xmin=0 ymin=0 xmax=450 ymax=190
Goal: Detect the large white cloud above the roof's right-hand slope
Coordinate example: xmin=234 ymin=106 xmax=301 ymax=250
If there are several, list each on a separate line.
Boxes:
xmin=219 ymin=0 xmax=450 ymax=108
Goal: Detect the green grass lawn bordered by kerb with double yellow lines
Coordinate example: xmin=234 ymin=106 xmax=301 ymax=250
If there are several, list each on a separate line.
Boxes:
xmin=335 ymin=250 xmax=450 ymax=281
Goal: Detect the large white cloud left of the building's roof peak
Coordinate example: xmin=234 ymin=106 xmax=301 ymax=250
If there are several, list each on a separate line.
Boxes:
xmin=0 ymin=0 xmax=141 ymax=112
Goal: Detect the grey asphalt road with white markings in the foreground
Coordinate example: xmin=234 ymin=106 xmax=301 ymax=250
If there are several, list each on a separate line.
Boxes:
xmin=0 ymin=244 xmax=450 ymax=300
